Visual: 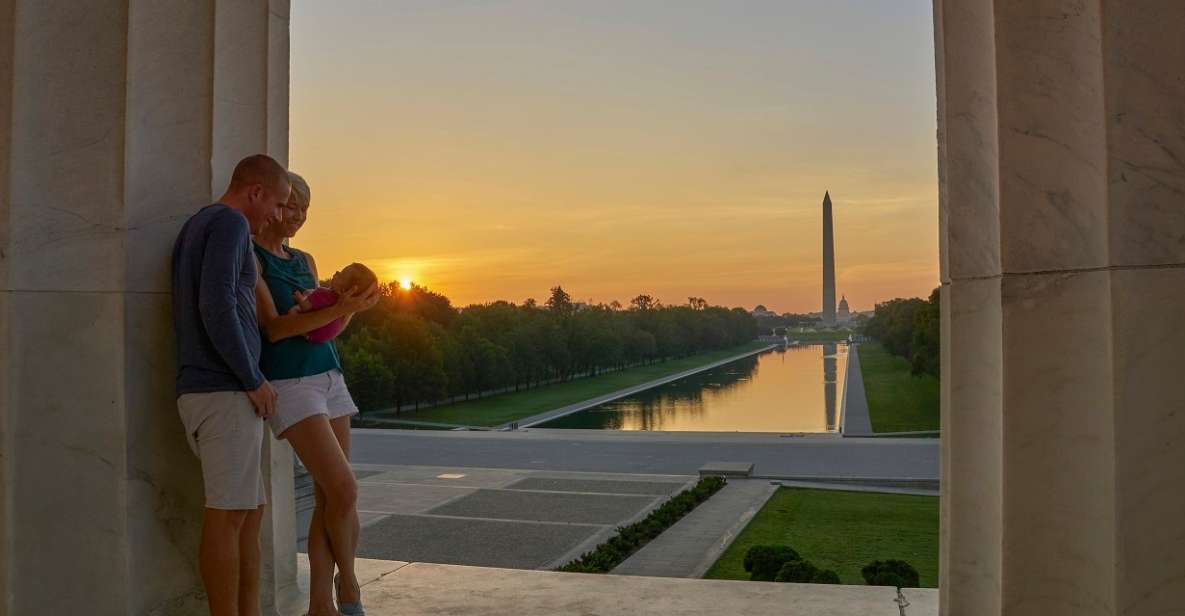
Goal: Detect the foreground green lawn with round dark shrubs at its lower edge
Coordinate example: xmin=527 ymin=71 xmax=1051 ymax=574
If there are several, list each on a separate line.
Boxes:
xmin=704 ymin=488 xmax=939 ymax=588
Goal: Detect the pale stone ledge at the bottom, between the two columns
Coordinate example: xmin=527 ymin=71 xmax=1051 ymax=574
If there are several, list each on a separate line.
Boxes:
xmin=302 ymin=559 xmax=939 ymax=616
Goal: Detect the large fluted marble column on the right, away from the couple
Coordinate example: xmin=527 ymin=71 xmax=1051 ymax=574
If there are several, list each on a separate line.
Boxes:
xmin=935 ymin=0 xmax=1185 ymax=616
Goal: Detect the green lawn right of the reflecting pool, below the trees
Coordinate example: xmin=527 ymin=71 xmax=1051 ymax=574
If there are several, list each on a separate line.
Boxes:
xmin=859 ymin=342 xmax=939 ymax=432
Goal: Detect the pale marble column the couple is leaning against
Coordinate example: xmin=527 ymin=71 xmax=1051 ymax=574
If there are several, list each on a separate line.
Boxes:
xmin=0 ymin=0 xmax=295 ymax=615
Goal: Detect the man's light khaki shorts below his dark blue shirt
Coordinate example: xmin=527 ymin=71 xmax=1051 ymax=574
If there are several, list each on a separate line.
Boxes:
xmin=177 ymin=391 xmax=268 ymax=509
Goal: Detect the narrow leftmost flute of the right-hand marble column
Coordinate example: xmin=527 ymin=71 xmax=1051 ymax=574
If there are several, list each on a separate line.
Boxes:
xmin=935 ymin=0 xmax=1004 ymax=616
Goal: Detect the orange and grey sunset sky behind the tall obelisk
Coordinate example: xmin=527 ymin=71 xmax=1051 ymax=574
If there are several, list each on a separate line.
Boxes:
xmin=289 ymin=0 xmax=939 ymax=313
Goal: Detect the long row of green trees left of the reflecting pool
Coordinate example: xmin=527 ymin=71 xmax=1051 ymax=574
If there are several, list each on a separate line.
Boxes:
xmin=337 ymin=283 xmax=758 ymax=411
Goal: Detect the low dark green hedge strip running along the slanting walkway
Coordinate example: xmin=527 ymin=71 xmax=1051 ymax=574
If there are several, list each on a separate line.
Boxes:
xmin=556 ymin=476 xmax=728 ymax=573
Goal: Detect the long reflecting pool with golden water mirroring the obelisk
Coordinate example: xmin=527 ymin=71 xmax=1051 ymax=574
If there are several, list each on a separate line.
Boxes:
xmin=540 ymin=344 xmax=847 ymax=432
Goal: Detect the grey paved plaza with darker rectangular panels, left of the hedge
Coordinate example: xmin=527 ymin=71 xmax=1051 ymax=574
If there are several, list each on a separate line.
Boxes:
xmin=343 ymin=464 xmax=696 ymax=569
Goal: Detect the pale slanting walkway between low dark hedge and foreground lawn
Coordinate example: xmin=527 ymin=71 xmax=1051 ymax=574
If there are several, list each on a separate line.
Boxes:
xmin=613 ymin=479 xmax=777 ymax=578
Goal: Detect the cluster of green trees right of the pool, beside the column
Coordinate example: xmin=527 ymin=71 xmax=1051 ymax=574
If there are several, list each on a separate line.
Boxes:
xmin=864 ymin=289 xmax=941 ymax=377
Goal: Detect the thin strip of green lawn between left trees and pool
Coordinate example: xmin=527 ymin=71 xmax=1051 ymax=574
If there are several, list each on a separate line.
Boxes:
xmin=367 ymin=341 xmax=769 ymax=426
